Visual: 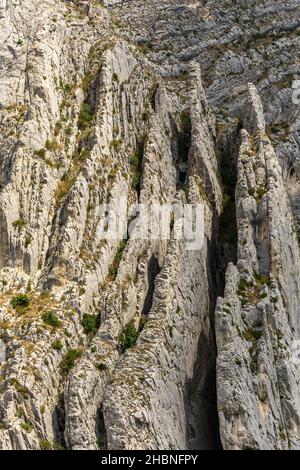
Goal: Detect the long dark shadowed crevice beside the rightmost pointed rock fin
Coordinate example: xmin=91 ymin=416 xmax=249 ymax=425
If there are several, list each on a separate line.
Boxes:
xmin=185 ymin=120 xmax=240 ymax=450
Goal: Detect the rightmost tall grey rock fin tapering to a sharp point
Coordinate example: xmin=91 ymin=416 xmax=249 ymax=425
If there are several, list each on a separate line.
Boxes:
xmin=216 ymin=85 xmax=300 ymax=449
